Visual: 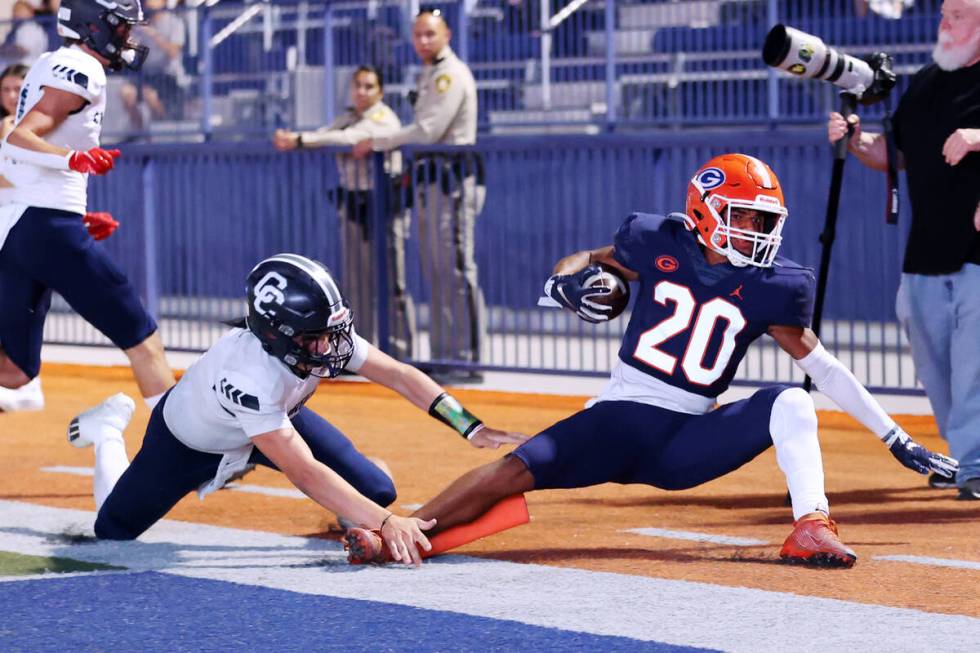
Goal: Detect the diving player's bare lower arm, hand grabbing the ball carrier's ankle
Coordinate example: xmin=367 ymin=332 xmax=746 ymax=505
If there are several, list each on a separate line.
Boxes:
xmin=252 ymin=428 xmax=436 ymax=565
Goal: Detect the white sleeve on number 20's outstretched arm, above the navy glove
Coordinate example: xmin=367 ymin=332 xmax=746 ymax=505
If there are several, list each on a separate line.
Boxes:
xmin=794 ymin=343 xmax=895 ymax=438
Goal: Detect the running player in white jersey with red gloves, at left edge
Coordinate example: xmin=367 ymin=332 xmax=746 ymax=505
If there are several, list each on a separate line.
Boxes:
xmin=0 ymin=0 xmax=174 ymax=406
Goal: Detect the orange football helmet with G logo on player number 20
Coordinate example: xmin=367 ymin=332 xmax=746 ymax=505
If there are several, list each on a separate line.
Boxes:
xmin=684 ymin=154 xmax=789 ymax=268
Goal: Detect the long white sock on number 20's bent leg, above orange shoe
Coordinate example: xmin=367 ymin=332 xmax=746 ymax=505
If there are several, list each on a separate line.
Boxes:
xmin=769 ymin=388 xmax=830 ymax=521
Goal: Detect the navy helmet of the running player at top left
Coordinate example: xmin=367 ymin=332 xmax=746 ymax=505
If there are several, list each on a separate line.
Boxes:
xmin=58 ymin=0 xmax=150 ymax=70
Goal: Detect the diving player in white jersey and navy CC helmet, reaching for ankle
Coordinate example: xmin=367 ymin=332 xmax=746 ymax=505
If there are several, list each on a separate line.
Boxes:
xmin=68 ymin=254 xmax=526 ymax=564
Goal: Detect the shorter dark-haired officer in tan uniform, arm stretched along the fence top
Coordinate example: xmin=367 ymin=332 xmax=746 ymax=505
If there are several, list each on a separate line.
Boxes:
xmin=272 ymin=66 xmax=415 ymax=359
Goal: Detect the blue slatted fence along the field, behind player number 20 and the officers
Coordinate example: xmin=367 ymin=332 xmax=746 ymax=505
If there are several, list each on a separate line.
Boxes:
xmin=45 ymin=130 xmax=915 ymax=391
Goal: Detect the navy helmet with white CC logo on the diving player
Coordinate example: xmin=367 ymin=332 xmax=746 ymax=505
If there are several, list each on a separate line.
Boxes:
xmin=246 ymin=254 xmax=354 ymax=378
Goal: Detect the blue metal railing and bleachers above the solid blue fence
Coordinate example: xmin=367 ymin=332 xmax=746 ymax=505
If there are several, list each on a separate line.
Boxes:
xmin=0 ymin=0 xmax=939 ymax=141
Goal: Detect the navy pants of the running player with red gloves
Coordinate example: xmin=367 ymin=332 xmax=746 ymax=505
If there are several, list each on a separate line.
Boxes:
xmin=0 ymin=207 xmax=157 ymax=378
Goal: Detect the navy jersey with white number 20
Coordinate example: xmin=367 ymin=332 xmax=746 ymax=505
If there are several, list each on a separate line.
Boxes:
xmin=614 ymin=213 xmax=815 ymax=397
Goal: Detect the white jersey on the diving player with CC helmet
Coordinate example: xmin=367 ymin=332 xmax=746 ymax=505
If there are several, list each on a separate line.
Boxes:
xmin=163 ymin=329 xmax=369 ymax=454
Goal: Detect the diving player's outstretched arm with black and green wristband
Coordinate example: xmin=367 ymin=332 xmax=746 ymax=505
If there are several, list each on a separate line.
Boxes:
xmin=357 ymin=345 xmax=527 ymax=449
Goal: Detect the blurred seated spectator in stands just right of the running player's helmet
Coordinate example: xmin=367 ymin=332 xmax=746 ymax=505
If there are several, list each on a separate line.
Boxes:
xmin=120 ymin=0 xmax=190 ymax=131
